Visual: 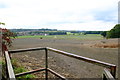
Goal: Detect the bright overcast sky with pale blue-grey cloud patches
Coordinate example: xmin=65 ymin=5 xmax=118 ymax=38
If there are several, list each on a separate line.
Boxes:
xmin=0 ymin=0 xmax=119 ymax=30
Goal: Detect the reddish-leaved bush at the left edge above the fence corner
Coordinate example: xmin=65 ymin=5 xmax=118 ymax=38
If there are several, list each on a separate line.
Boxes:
xmin=0 ymin=24 xmax=16 ymax=52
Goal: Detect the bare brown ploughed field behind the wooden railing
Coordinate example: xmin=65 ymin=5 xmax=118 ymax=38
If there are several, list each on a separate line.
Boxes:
xmin=10 ymin=38 xmax=118 ymax=78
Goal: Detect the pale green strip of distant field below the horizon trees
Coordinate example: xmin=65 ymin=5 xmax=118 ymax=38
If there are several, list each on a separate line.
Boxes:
xmin=17 ymin=34 xmax=103 ymax=40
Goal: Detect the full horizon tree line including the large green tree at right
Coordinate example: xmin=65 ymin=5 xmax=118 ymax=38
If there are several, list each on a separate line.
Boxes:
xmin=7 ymin=24 xmax=120 ymax=38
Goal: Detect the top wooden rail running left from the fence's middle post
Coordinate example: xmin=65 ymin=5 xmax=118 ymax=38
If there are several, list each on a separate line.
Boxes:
xmin=8 ymin=47 xmax=46 ymax=53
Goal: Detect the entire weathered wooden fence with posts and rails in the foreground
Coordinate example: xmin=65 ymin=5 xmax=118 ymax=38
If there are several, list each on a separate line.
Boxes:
xmin=5 ymin=47 xmax=116 ymax=80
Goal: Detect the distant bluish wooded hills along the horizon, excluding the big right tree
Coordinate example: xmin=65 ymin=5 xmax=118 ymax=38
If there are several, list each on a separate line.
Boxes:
xmin=10 ymin=29 xmax=103 ymax=36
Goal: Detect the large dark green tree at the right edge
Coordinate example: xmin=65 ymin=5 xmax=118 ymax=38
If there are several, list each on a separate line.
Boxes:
xmin=107 ymin=24 xmax=120 ymax=38
